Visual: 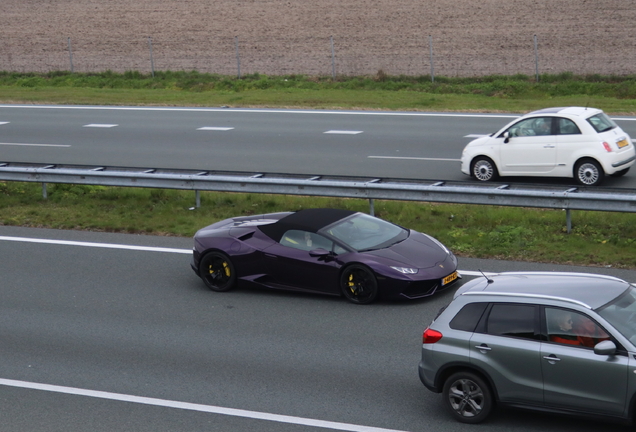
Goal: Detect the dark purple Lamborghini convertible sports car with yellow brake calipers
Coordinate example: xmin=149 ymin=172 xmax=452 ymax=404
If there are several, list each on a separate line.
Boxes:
xmin=191 ymin=209 xmax=460 ymax=304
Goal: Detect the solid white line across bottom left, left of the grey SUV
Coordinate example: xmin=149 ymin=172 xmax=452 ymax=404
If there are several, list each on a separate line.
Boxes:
xmin=0 ymin=378 xmax=404 ymax=432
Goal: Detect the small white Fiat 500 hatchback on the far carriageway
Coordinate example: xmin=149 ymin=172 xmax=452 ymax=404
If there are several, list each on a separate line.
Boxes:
xmin=462 ymin=107 xmax=636 ymax=186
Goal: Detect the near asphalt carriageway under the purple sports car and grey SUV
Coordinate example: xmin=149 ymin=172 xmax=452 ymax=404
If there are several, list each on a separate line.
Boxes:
xmin=0 ymin=227 xmax=636 ymax=432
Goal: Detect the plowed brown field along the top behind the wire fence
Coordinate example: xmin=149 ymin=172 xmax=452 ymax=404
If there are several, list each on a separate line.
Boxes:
xmin=0 ymin=0 xmax=636 ymax=76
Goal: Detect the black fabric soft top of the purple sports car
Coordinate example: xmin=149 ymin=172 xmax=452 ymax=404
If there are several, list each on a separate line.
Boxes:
xmin=258 ymin=208 xmax=357 ymax=241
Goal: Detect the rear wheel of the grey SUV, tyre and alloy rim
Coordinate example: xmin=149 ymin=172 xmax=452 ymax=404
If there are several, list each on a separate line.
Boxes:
xmin=442 ymin=371 xmax=494 ymax=424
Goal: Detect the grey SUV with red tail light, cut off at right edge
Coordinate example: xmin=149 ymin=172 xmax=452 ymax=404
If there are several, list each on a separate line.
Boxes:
xmin=419 ymin=273 xmax=636 ymax=423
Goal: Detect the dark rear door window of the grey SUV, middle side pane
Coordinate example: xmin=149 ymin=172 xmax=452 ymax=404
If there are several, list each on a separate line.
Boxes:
xmin=485 ymin=303 xmax=541 ymax=340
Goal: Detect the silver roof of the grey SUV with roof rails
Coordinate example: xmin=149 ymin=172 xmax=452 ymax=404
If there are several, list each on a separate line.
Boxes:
xmin=455 ymin=272 xmax=630 ymax=309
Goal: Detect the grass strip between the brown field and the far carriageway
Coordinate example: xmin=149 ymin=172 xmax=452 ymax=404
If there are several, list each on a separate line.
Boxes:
xmin=0 ymin=71 xmax=636 ymax=114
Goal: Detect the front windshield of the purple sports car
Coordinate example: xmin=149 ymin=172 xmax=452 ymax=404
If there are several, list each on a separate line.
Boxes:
xmin=325 ymin=213 xmax=409 ymax=251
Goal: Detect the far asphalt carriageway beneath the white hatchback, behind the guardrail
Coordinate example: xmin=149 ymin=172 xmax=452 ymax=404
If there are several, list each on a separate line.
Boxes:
xmin=0 ymin=105 xmax=636 ymax=188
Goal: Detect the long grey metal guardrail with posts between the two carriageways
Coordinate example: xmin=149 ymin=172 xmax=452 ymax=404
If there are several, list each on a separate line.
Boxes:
xmin=0 ymin=162 xmax=636 ymax=232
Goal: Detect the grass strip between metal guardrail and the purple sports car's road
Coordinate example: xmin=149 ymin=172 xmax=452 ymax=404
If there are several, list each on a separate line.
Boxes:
xmin=0 ymin=182 xmax=636 ymax=269
